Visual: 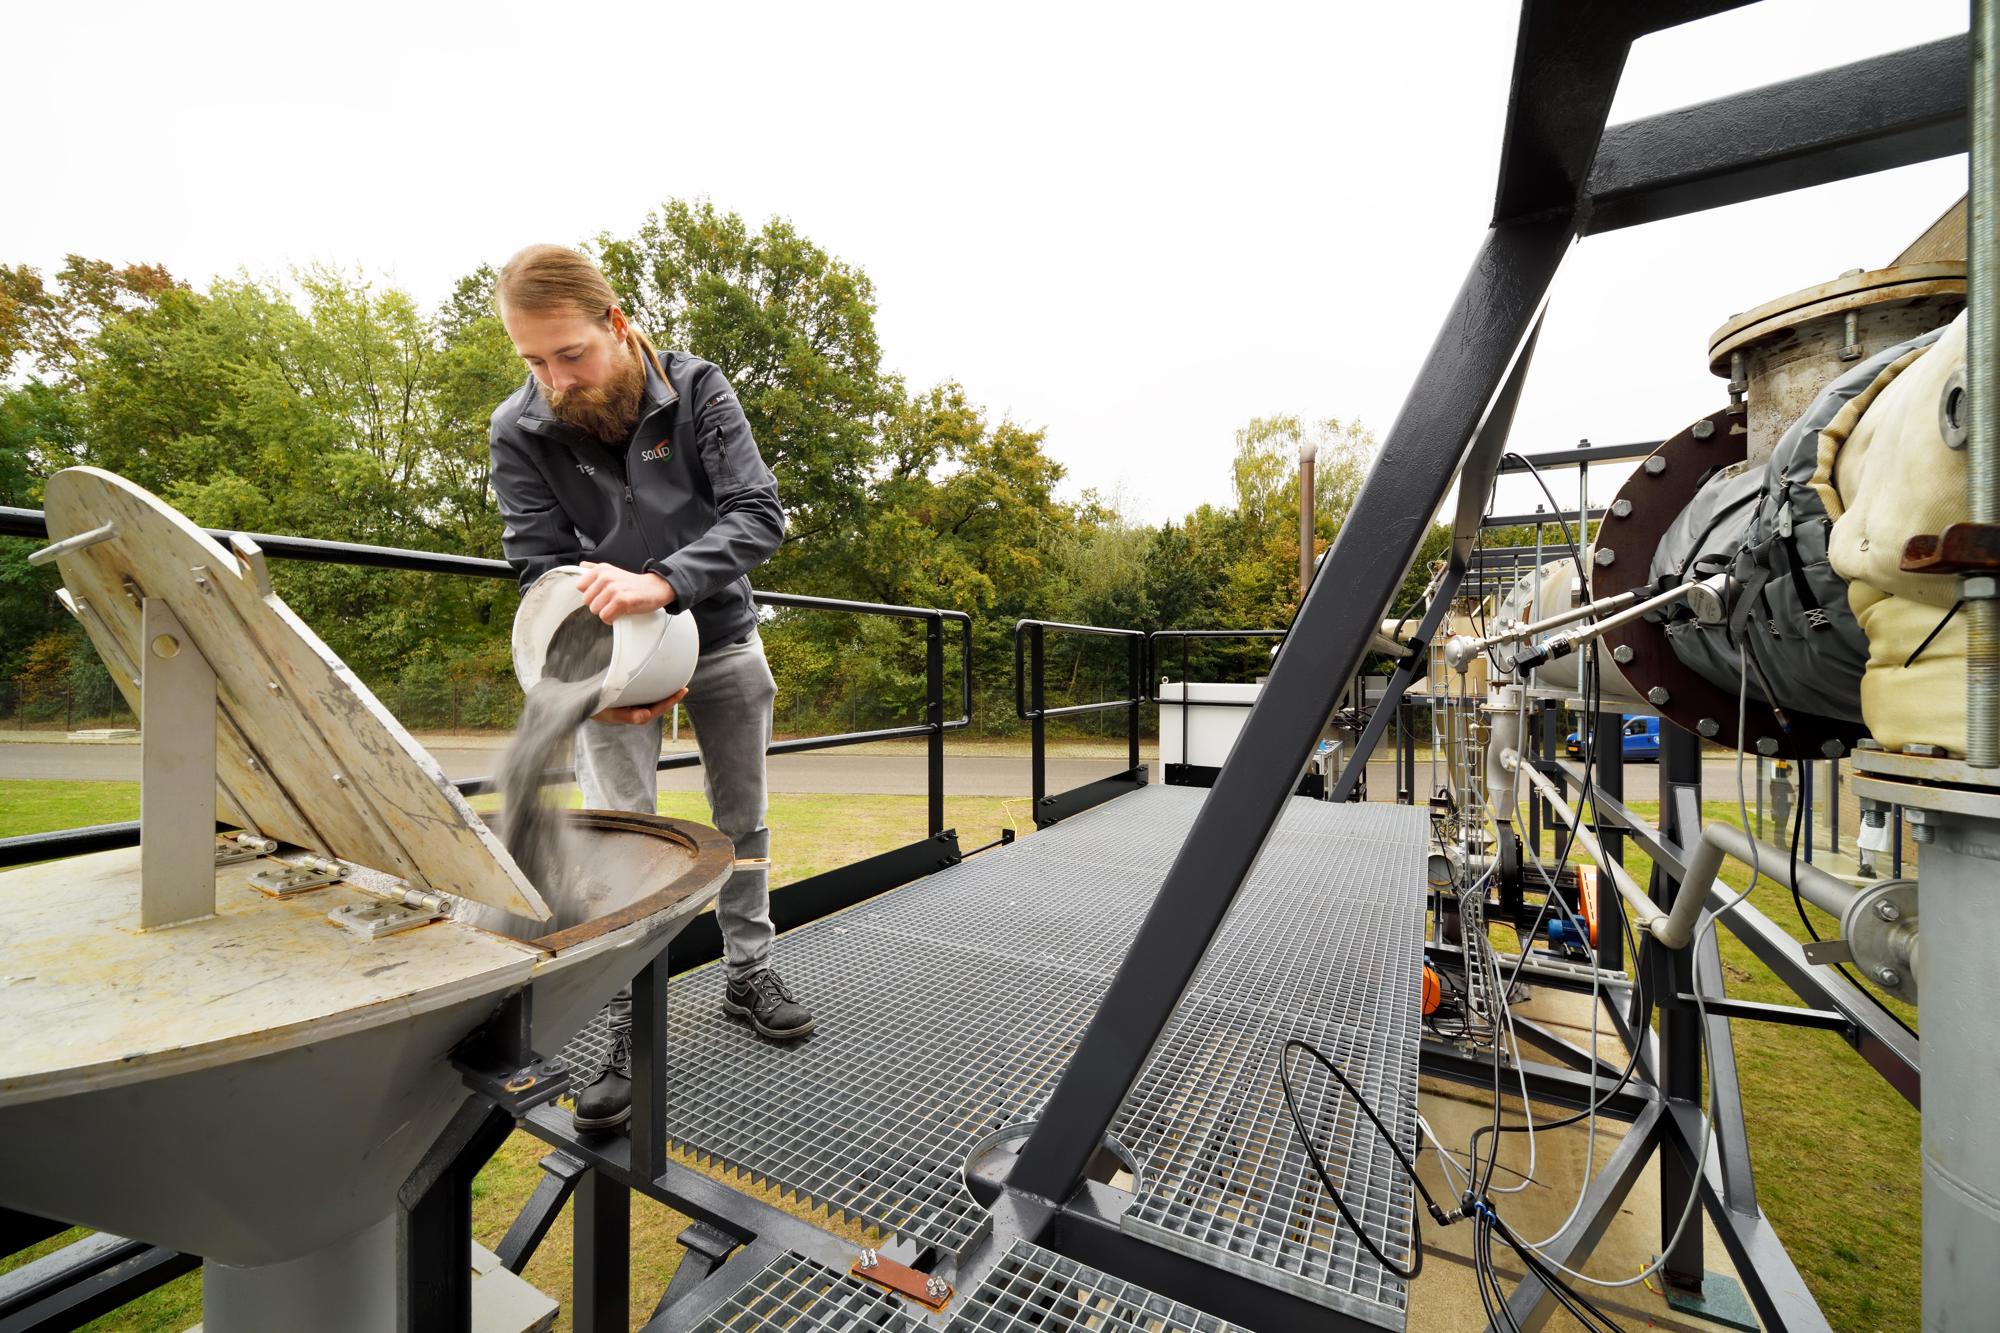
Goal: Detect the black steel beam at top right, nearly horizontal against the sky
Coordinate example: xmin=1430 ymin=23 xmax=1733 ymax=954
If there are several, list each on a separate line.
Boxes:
xmin=1584 ymin=34 xmax=1972 ymax=234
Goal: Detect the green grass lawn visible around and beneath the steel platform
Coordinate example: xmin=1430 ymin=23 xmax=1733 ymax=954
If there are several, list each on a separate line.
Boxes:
xmin=0 ymin=781 xmax=1922 ymax=1333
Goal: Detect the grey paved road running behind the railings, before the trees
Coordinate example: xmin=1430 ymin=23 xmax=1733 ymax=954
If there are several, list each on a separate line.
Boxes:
xmin=0 ymin=743 xmax=1754 ymax=801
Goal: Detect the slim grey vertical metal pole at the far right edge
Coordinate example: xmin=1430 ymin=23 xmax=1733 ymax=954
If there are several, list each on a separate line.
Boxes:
xmin=1960 ymin=0 xmax=2000 ymax=769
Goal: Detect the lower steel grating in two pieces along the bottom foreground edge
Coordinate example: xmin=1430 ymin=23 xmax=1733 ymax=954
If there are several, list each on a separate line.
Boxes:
xmin=696 ymin=1241 xmax=1238 ymax=1333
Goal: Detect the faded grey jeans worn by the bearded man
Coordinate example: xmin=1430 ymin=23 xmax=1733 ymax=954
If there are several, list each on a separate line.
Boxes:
xmin=576 ymin=630 xmax=778 ymax=984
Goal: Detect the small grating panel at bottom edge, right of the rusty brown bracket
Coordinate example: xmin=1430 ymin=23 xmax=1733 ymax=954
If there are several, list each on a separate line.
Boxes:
xmin=946 ymin=1241 xmax=1236 ymax=1333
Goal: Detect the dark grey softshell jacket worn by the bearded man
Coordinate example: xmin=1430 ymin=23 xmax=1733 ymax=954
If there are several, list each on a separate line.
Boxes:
xmin=490 ymin=352 xmax=784 ymax=648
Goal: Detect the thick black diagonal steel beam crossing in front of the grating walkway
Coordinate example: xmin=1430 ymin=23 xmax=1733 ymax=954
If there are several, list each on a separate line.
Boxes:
xmin=1016 ymin=216 xmax=1572 ymax=1201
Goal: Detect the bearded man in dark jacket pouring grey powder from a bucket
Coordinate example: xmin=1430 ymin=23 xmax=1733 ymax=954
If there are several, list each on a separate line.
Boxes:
xmin=490 ymin=246 xmax=812 ymax=1129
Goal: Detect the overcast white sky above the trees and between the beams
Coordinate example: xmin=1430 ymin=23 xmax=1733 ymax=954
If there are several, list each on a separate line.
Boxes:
xmin=0 ymin=0 xmax=1966 ymax=520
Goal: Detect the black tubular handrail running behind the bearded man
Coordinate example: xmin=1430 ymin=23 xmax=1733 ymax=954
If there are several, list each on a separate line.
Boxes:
xmin=0 ymin=506 xmax=972 ymax=867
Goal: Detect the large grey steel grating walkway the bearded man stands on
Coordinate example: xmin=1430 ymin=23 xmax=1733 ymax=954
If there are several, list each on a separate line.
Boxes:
xmin=668 ymin=787 xmax=1430 ymax=1327
